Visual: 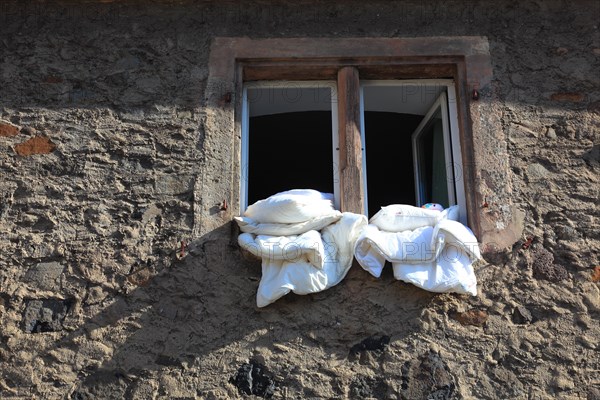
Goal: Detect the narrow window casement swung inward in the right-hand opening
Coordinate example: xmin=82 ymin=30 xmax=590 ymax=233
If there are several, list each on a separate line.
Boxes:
xmin=412 ymin=93 xmax=456 ymax=208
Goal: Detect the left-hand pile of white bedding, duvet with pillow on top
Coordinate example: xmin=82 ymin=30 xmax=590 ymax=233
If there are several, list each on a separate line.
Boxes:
xmin=235 ymin=189 xmax=367 ymax=307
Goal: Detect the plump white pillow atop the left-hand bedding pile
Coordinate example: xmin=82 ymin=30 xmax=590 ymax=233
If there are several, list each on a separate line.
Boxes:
xmin=243 ymin=189 xmax=335 ymax=224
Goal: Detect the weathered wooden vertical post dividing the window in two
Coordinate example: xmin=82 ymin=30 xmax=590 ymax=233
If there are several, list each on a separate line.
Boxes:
xmin=338 ymin=67 xmax=367 ymax=214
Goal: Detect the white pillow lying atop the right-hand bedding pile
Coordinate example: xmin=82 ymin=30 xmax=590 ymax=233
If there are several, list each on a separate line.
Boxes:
xmin=369 ymin=204 xmax=458 ymax=232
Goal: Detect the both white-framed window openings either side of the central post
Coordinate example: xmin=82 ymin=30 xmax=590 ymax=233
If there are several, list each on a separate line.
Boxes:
xmin=241 ymin=79 xmax=466 ymax=222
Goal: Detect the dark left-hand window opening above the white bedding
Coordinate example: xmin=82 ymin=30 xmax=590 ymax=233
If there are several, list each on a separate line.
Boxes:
xmin=242 ymin=82 xmax=334 ymax=206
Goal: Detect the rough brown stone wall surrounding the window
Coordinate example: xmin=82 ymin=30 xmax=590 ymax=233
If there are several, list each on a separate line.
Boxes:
xmin=0 ymin=0 xmax=600 ymax=399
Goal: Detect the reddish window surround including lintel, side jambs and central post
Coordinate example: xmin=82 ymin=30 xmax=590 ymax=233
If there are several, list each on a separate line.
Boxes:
xmin=204 ymin=37 xmax=514 ymax=250
